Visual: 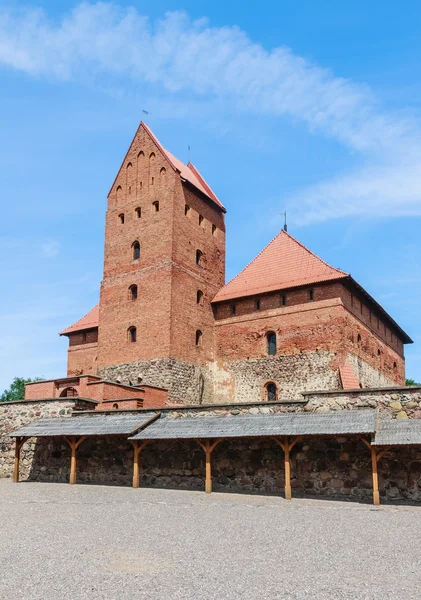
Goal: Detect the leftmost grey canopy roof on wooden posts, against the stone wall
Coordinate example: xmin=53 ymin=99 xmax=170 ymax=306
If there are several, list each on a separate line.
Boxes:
xmin=10 ymin=412 xmax=159 ymax=437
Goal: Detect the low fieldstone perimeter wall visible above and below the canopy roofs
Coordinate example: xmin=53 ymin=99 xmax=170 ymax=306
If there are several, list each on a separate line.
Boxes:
xmin=4 ymin=388 xmax=421 ymax=502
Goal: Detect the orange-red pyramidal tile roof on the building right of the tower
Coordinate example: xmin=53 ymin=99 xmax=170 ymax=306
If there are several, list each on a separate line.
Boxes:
xmin=213 ymin=231 xmax=348 ymax=302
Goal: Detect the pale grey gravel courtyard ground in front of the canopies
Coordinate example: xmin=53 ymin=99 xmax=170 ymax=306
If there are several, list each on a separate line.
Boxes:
xmin=0 ymin=480 xmax=421 ymax=600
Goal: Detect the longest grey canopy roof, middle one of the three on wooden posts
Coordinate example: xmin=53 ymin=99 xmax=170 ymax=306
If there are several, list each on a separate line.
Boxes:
xmin=131 ymin=410 xmax=376 ymax=440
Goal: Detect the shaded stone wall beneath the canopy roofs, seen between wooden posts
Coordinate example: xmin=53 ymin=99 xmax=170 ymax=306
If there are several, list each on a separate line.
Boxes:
xmin=21 ymin=437 xmax=421 ymax=502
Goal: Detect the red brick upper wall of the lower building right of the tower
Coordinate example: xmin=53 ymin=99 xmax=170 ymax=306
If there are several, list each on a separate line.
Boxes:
xmin=216 ymin=298 xmax=404 ymax=385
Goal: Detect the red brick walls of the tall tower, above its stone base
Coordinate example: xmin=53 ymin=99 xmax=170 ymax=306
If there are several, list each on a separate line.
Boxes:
xmin=98 ymin=123 xmax=225 ymax=369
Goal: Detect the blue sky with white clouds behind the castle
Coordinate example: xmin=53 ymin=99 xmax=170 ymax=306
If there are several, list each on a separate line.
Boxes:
xmin=0 ymin=0 xmax=421 ymax=390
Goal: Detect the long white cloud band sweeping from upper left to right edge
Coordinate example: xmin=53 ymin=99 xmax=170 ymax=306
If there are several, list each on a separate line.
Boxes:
xmin=0 ymin=2 xmax=421 ymax=222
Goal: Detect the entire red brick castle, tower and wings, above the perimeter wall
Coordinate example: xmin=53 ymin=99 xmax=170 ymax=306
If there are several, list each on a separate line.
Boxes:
xmin=26 ymin=123 xmax=411 ymax=409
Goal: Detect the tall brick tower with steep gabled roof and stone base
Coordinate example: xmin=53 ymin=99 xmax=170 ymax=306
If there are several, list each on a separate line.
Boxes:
xmin=97 ymin=123 xmax=226 ymax=402
